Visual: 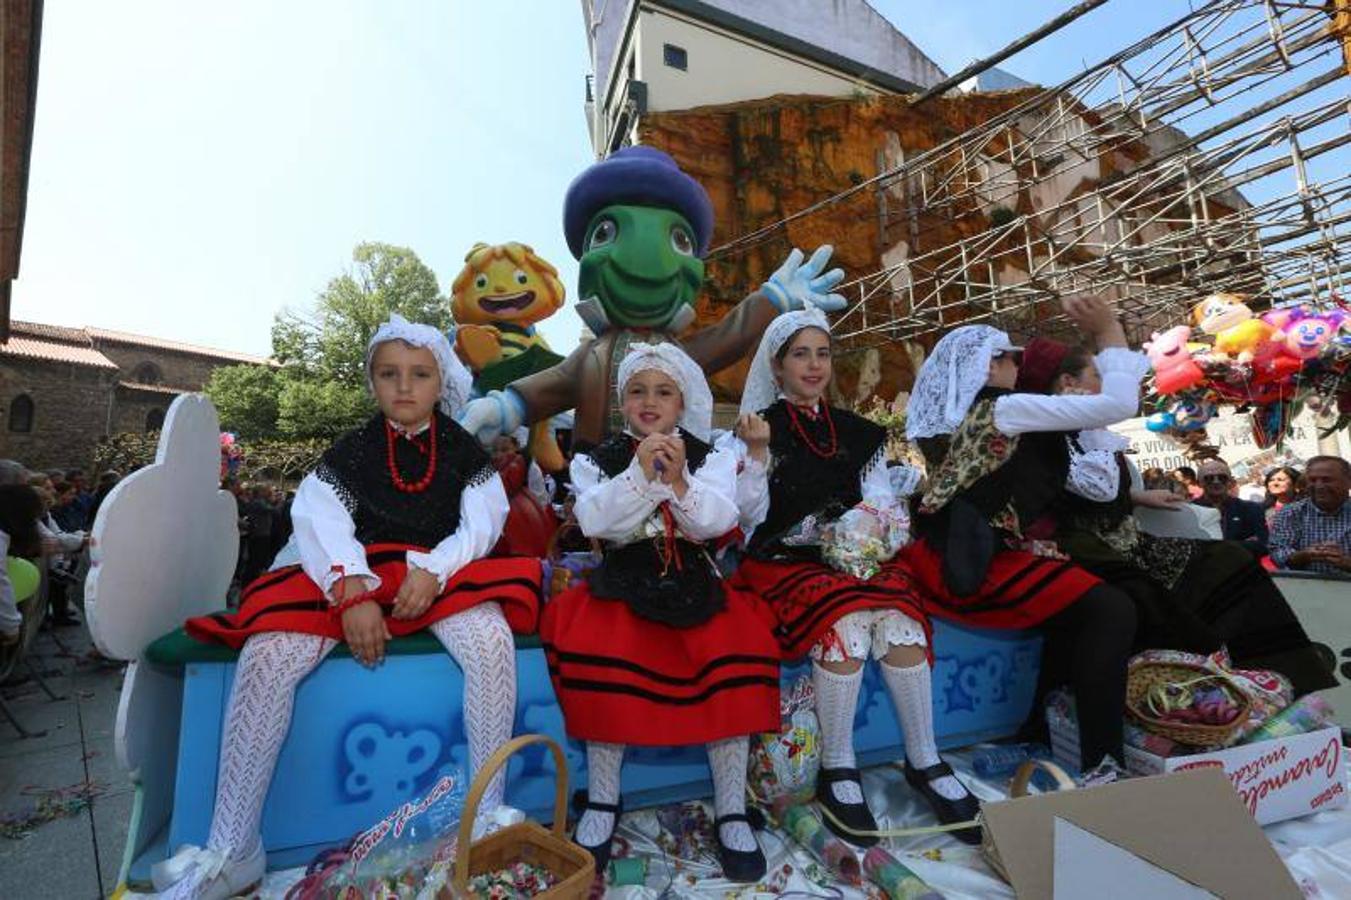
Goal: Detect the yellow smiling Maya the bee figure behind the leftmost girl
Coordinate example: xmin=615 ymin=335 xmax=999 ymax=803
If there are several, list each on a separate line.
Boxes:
xmin=450 ymin=241 xmax=565 ymax=472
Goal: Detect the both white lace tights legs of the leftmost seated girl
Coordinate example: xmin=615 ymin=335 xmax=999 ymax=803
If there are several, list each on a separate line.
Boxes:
xmin=198 ymin=603 xmax=516 ymax=864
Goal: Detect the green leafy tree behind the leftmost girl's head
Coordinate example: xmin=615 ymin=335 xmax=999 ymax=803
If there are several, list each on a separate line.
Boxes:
xmin=207 ymin=242 xmax=451 ymax=441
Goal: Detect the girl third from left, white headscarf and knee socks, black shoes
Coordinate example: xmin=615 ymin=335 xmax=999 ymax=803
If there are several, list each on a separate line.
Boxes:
xmin=736 ymin=309 xmax=978 ymax=846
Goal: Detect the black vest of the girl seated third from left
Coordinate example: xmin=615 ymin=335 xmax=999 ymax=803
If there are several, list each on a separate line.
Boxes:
xmin=747 ymin=400 xmax=886 ymax=561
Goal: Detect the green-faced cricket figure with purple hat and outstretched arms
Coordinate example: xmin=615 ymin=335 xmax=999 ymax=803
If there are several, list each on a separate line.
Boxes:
xmin=459 ymin=146 xmax=846 ymax=443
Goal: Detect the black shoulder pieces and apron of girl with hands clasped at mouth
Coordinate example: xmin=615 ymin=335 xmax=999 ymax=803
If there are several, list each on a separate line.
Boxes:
xmin=586 ymin=431 xmax=727 ymax=628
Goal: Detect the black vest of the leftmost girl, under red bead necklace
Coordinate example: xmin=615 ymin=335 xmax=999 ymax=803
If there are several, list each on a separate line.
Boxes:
xmin=315 ymin=411 xmax=496 ymax=549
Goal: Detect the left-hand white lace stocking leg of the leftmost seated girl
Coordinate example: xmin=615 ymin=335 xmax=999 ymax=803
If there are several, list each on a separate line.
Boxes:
xmin=159 ymin=631 xmax=338 ymax=900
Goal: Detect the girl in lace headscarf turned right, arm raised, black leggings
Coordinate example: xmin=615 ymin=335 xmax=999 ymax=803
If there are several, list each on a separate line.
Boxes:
xmin=902 ymin=297 xmax=1148 ymax=769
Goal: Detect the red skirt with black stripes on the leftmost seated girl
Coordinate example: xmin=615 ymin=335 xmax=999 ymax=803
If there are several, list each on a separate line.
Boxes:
xmin=184 ymin=543 xmax=543 ymax=650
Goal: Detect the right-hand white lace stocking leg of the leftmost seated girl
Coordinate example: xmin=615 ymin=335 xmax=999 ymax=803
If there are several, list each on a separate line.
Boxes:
xmin=431 ymin=603 xmax=516 ymax=812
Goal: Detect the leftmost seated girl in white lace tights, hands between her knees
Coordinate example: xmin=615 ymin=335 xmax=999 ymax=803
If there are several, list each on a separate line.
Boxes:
xmin=170 ymin=315 xmax=542 ymax=899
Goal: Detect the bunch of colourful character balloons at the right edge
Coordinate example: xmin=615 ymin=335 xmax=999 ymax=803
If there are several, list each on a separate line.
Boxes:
xmin=1144 ymin=293 xmax=1351 ymax=449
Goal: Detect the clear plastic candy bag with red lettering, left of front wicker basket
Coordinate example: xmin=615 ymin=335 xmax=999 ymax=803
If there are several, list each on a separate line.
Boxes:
xmin=286 ymin=774 xmax=465 ymax=900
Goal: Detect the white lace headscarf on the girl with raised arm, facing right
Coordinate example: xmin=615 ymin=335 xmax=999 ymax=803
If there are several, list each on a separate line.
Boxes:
xmin=905 ymin=326 xmax=1017 ymax=441
